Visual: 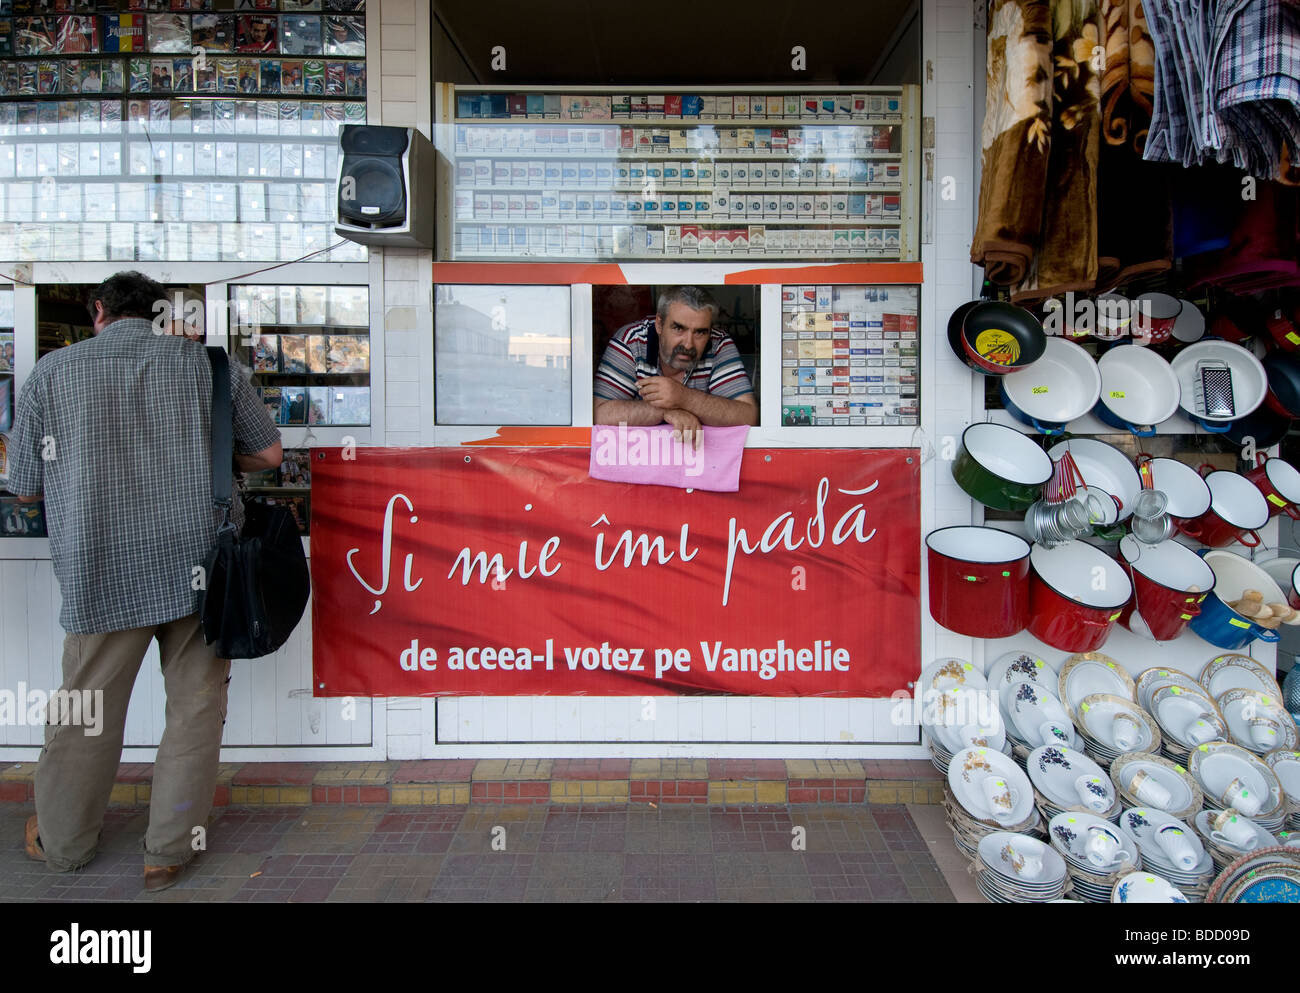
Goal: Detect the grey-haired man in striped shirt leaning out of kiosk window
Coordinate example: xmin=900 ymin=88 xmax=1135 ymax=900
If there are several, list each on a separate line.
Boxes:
xmin=593 ymin=286 xmax=758 ymax=446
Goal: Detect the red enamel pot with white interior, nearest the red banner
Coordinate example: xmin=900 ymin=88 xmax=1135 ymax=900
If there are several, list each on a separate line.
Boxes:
xmin=926 ymin=526 xmax=1030 ymax=638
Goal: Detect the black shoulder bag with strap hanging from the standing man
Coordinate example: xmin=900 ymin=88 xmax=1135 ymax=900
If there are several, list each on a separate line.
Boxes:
xmin=199 ymin=347 xmax=311 ymax=659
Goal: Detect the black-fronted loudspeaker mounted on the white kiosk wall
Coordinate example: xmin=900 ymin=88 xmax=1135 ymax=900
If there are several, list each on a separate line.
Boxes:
xmin=334 ymin=125 xmax=434 ymax=248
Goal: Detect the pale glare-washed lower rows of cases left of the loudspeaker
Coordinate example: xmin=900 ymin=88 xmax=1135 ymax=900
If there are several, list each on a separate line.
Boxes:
xmin=0 ymin=99 xmax=365 ymax=261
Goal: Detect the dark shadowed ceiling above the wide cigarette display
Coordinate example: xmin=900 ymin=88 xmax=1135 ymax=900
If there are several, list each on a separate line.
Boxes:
xmin=434 ymin=0 xmax=918 ymax=86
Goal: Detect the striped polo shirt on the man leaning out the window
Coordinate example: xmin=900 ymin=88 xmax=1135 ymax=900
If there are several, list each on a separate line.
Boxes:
xmin=595 ymin=317 xmax=754 ymax=400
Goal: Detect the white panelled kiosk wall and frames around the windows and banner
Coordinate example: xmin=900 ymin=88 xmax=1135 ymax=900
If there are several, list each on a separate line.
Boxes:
xmin=0 ymin=0 xmax=1275 ymax=762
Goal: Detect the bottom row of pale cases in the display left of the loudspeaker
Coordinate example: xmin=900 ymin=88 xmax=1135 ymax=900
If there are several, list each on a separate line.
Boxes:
xmin=0 ymin=221 xmax=365 ymax=263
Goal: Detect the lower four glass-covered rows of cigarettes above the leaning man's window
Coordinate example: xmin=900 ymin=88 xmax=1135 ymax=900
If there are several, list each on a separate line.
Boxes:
xmin=450 ymin=115 xmax=909 ymax=261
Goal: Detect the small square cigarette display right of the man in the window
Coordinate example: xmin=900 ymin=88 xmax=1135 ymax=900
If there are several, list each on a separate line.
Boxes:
xmin=781 ymin=286 xmax=920 ymax=428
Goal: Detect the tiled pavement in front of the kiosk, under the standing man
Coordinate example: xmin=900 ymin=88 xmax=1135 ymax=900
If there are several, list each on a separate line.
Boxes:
xmin=0 ymin=803 xmax=954 ymax=903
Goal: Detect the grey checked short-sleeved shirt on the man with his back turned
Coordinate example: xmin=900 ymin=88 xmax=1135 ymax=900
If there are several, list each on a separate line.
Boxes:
xmin=9 ymin=318 xmax=280 ymax=634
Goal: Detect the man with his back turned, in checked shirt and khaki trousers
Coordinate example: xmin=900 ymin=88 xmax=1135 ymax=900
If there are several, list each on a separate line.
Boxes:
xmin=9 ymin=273 xmax=282 ymax=890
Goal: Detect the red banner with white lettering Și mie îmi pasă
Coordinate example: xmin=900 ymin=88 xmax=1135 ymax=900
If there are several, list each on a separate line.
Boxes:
xmin=311 ymin=448 xmax=920 ymax=697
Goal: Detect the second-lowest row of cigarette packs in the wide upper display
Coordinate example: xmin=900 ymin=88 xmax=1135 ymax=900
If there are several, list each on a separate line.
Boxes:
xmin=455 ymin=190 xmax=901 ymax=224
